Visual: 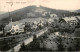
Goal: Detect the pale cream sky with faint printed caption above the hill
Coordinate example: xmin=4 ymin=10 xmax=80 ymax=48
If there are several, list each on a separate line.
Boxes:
xmin=0 ymin=0 xmax=80 ymax=12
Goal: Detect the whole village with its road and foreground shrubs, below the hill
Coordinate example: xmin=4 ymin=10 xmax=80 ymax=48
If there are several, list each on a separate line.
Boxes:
xmin=0 ymin=6 xmax=80 ymax=52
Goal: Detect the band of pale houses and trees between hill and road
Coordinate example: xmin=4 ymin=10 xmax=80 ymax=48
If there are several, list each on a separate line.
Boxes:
xmin=1 ymin=12 xmax=80 ymax=36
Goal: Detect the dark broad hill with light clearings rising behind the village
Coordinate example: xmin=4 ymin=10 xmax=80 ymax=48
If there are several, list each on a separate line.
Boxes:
xmin=0 ymin=6 xmax=80 ymax=23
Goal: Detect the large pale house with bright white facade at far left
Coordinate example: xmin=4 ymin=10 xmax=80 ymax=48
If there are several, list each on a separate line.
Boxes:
xmin=4 ymin=22 xmax=25 ymax=34
